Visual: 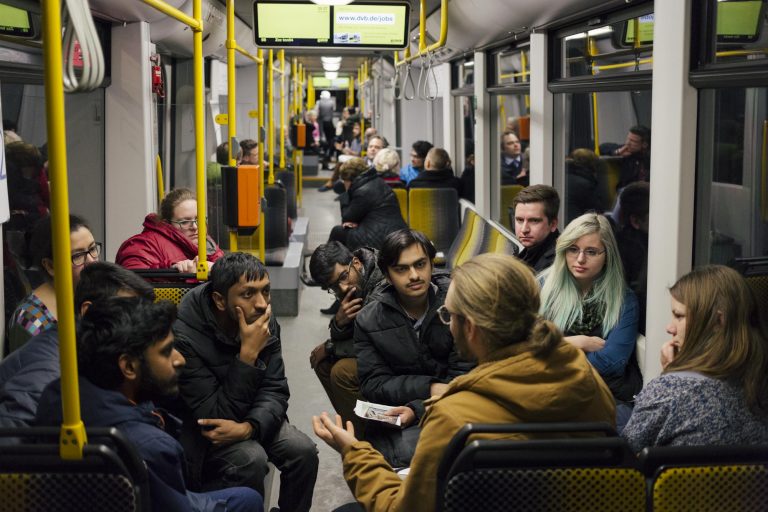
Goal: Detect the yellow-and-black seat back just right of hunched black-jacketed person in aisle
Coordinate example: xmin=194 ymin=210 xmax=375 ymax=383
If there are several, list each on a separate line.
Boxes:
xmin=408 ymin=188 xmax=459 ymax=253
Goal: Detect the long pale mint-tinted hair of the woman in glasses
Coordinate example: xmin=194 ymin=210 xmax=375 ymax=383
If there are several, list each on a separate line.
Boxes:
xmin=540 ymin=213 xmax=626 ymax=336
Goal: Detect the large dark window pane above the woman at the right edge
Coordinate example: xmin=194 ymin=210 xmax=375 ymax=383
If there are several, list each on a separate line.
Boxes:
xmin=694 ymin=88 xmax=768 ymax=265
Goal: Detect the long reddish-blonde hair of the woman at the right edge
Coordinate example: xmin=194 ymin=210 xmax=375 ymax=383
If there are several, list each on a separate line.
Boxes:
xmin=664 ymin=265 xmax=768 ymax=412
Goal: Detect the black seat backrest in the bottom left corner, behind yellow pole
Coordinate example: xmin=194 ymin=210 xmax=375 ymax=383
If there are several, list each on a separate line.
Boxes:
xmin=0 ymin=427 xmax=151 ymax=512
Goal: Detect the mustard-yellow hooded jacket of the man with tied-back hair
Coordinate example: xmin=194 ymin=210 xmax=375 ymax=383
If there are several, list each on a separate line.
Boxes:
xmin=342 ymin=342 xmax=615 ymax=512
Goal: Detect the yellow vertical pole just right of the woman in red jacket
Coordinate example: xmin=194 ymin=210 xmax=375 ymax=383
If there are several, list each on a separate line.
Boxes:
xmin=192 ymin=0 xmax=208 ymax=281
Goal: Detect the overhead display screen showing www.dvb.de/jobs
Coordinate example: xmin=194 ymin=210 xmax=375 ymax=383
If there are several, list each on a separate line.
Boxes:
xmin=253 ymin=0 xmax=410 ymax=49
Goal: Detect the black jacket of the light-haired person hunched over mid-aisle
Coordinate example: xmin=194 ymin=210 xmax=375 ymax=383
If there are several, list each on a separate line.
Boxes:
xmin=339 ymin=168 xmax=408 ymax=251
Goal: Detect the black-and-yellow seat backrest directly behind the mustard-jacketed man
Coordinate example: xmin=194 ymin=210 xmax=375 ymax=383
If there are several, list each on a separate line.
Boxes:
xmin=437 ymin=424 xmax=646 ymax=512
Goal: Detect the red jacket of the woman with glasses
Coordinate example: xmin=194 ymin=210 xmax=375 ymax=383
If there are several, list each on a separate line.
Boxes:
xmin=115 ymin=213 xmax=224 ymax=269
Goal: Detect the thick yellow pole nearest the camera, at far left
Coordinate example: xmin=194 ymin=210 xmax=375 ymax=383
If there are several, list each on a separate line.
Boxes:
xmin=43 ymin=0 xmax=88 ymax=459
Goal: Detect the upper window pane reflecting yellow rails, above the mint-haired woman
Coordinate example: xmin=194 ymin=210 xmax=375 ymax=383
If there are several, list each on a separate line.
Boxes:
xmin=560 ymin=13 xmax=654 ymax=78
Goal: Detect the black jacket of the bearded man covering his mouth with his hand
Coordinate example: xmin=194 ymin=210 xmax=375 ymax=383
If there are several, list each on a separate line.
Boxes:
xmin=173 ymin=283 xmax=290 ymax=442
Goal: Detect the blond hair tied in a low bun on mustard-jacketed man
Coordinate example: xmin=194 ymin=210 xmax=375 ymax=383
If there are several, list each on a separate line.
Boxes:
xmin=452 ymin=253 xmax=562 ymax=355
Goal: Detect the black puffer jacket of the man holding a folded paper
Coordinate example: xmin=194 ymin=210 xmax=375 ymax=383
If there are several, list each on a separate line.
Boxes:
xmin=355 ymin=271 xmax=474 ymax=417
